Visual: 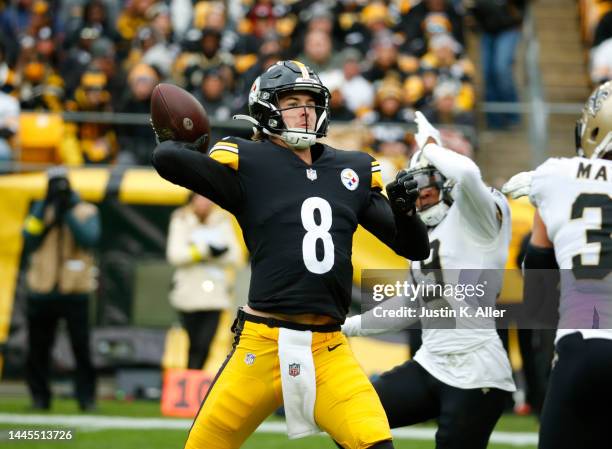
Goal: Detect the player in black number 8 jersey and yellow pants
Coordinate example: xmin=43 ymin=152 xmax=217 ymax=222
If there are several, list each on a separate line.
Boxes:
xmin=153 ymin=61 xmax=429 ymax=449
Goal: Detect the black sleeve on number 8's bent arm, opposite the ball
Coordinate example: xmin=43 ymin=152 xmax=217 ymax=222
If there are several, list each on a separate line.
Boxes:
xmin=359 ymin=190 xmax=429 ymax=260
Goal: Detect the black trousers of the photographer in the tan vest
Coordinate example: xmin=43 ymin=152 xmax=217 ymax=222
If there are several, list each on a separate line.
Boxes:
xmin=26 ymin=294 xmax=96 ymax=408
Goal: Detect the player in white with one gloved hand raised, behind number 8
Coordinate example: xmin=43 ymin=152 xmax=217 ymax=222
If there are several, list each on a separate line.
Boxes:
xmin=342 ymin=112 xmax=515 ymax=449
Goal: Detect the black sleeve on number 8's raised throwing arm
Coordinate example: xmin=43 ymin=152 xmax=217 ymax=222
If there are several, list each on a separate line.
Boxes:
xmin=152 ymin=140 xmax=244 ymax=214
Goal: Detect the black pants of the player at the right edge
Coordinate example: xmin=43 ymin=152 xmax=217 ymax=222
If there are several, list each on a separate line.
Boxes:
xmin=538 ymin=332 xmax=612 ymax=449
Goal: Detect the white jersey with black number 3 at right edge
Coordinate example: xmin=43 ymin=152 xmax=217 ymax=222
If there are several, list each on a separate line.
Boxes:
xmin=530 ymin=157 xmax=612 ymax=340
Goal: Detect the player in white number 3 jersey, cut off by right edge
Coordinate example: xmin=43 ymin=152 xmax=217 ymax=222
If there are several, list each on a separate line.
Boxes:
xmin=503 ymin=81 xmax=612 ymax=449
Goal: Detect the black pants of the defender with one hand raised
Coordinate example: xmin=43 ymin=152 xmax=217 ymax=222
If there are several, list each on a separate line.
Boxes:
xmin=374 ymin=360 xmax=510 ymax=449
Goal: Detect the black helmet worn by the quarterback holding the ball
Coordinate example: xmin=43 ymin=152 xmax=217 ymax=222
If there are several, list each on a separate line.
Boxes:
xmin=243 ymin=61 xmax=330 ymax=149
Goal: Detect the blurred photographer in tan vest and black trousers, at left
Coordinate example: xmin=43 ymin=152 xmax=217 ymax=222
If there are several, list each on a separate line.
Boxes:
xmin=23 ymin=167 xmax=100 ymax=411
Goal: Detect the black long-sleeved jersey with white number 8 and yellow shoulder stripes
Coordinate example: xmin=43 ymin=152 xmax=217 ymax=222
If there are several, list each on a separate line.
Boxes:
xmin=153 ymin=137 xmax=429 ymax=322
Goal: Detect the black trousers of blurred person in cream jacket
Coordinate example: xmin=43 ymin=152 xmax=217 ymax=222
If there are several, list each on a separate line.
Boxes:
xmin=180 ymin=310 xmax=221 ymax=369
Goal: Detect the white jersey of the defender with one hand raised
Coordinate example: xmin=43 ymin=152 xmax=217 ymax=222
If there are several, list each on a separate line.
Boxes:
xmin=411 ymin=184 xmax=515 ymax=391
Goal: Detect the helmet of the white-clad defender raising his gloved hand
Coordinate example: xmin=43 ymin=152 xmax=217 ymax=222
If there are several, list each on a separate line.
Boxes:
xmin=407 ymin=151 xmax=453 ymax=227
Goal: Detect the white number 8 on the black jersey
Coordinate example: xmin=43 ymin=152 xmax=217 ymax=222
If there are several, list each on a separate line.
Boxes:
xmin=301 ymin=196 xmax=334 ymax=274
